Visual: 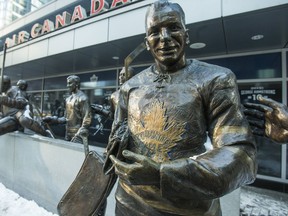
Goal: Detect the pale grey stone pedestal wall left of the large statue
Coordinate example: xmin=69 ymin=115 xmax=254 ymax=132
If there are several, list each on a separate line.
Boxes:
xmin=0 ymin=132 xmax=98 ymax=213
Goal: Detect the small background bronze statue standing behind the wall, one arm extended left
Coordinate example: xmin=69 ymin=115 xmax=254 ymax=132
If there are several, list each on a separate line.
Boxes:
xmin=43 ymin=75 xmax=91 ymax=155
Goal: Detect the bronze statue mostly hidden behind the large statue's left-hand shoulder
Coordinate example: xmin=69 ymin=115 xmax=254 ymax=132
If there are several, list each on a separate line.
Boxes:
xmin=91 ymin=67 xmax=134 ymax=119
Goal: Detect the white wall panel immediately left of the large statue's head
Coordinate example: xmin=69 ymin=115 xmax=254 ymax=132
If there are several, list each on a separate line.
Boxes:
xmin=109 ymin=7 xmax=146 ymax=41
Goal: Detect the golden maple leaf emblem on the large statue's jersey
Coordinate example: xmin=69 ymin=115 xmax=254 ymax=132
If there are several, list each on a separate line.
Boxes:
xmin=129 ymin=101 xmax=185 ymax=162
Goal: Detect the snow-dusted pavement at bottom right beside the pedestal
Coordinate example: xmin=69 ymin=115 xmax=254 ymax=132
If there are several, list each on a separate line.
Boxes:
xmin=240 ymin=186 xmax=288 ymax=216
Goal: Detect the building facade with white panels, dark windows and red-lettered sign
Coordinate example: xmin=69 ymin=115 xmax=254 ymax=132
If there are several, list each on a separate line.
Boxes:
xmin=0 ymin=0 xmax=288 ymax=192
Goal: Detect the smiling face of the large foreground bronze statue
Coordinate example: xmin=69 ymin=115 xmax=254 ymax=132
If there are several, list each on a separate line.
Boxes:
xmin=146 ymin=7 xmax=187 ymax=66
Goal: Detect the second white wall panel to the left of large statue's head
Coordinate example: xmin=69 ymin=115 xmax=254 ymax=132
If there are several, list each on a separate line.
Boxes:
xmin=74 ymin=19 xmax=108 ymax=49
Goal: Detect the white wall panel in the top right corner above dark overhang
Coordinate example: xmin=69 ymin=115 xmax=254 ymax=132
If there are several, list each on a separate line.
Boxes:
xmin=222 ymin=0 xmax=288 ymax=16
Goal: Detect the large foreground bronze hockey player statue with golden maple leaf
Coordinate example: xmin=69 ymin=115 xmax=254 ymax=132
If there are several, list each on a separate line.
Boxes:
xmin=104 ymin=0 xmax=256 ymax=216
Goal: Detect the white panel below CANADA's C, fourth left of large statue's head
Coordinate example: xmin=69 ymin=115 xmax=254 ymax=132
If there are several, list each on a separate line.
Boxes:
xmin=28 ymin=40 xmax=48 ymax=61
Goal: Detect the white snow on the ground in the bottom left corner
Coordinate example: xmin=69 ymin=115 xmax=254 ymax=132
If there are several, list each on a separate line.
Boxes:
xmin=0 ymin=183 xmax=57 ymax=216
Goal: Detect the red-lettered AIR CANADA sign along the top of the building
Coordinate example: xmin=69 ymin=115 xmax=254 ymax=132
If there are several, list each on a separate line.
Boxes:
xmin=5 ymin=0 xmax=135 ymax=48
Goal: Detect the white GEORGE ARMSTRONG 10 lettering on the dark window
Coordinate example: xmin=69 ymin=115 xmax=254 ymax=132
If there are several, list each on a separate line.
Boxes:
xmin=240 ymin=86 xmax=276 ymax=101
